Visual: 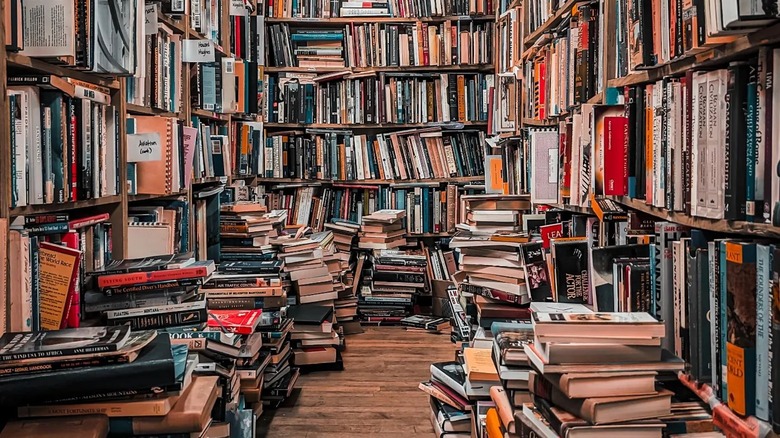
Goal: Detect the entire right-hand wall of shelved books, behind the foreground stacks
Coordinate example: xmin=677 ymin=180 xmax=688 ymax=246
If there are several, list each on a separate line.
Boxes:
xmin=482 ymin=0 xmax=780 ymax=436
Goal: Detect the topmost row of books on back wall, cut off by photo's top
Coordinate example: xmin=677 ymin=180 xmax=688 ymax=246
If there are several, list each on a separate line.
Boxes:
xmin=266 ymin=0 xmax=493 ymax=18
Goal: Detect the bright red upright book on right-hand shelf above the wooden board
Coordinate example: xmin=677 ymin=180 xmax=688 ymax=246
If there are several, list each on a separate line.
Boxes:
xmin=602 ymin=116 xmax=628 ymax=196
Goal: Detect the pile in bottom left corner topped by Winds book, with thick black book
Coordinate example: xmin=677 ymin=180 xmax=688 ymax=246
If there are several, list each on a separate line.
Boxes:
xmin=0 ymin=325 xmax=229 ymax=437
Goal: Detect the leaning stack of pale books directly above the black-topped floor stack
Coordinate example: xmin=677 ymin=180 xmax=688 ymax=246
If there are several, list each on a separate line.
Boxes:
xmin=272 ymin=228 xmax=338 ymax=305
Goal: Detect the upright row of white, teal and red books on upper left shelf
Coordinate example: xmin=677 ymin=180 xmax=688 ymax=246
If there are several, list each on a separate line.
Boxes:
xmin=8 ymin=75 xmax=123 ymax=207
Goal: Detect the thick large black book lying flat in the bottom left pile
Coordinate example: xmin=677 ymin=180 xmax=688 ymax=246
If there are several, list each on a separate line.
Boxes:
xmin=0 ymin=336 xmax=176 ymax=407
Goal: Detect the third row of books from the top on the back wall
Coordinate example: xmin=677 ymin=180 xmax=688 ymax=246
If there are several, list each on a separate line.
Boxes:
xmin=264 ymin=73 xmax=494 ymax=124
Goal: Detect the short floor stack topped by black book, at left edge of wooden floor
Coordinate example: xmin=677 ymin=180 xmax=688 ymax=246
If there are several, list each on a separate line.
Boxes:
xmin=289 ymin=304 xmax=344 ymax=371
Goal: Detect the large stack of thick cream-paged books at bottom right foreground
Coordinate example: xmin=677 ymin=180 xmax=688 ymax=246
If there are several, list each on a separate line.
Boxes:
xmin=516 ymin=312 xmax=685 ymax=437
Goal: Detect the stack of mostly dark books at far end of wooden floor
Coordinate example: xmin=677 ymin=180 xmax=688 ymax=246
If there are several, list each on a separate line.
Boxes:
xmin=358 ymin=250 xmax=428 ymax=324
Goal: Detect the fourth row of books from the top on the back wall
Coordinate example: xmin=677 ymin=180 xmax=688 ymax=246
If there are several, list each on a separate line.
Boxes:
xmin=262 ymin=128 xmax=485 ymax=181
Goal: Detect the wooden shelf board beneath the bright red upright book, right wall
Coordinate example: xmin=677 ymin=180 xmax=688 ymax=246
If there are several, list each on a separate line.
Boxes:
xmin=609 ymin=196 xmax=780 ymax=237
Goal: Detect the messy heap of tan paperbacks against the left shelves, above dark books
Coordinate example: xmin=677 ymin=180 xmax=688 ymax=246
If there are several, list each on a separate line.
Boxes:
xmin=219 ymin=202 xmax=287 ymax=261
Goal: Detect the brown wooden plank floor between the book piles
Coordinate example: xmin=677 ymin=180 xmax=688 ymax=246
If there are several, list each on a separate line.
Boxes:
xmin=258 ymin=327 xmax=455 ymax=438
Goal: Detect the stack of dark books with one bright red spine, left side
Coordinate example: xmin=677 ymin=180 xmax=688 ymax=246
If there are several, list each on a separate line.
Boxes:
xmin=84 ymin=253 xmax=215 ymax=330
